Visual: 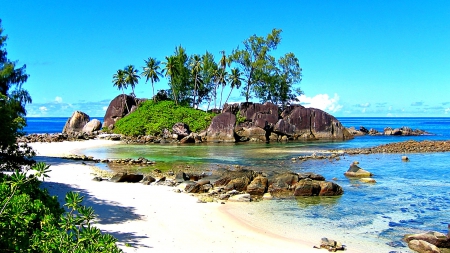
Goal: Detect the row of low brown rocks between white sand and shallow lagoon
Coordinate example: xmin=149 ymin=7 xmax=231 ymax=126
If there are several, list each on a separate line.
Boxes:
xmin=97 ymin=166 xmax=344 ymax=201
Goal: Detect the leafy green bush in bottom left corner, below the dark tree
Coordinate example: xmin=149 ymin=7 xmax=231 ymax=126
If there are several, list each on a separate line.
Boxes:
xmin=0 ymin=163 xmax=121 ymax=252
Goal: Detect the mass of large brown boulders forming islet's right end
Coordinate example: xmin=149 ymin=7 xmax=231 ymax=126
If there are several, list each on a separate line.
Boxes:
xmin=207 ymin=102 xmax=353 ymax=142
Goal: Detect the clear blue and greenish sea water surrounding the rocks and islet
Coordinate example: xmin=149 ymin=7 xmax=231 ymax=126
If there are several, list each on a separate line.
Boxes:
xmin=25 ymin=118 xmax=450 ymax=252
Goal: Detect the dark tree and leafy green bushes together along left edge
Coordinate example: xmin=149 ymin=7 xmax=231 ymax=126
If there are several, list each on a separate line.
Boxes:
xmin=0 ymin=20 xmax=121 ymax=252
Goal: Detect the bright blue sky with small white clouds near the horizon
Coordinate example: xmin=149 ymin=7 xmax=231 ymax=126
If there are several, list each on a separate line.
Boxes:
xmin=0 ymin=0 xmax=450 ymax=117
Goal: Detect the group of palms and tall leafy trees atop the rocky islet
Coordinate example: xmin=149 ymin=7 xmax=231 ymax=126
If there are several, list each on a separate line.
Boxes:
xmin=113 ymin=29 xmax=303 ymax=111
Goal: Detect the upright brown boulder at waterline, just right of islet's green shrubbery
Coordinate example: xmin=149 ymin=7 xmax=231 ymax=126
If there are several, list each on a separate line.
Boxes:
xmin=206 ymin=112 xmax=236 ymax=142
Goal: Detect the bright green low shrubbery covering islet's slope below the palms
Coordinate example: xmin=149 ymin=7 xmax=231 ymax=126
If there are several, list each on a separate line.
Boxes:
xmin=114 ymin=100 xmax=215 ymax=136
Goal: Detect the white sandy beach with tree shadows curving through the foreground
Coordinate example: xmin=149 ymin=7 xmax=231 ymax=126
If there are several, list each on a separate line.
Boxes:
xmin=30 ymin=140 xmax=326 ymax=252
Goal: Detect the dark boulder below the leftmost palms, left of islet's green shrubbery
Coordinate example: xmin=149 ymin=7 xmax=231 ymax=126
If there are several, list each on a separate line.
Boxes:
xmin=103 ymin=94 xmax=141 ymax=129
